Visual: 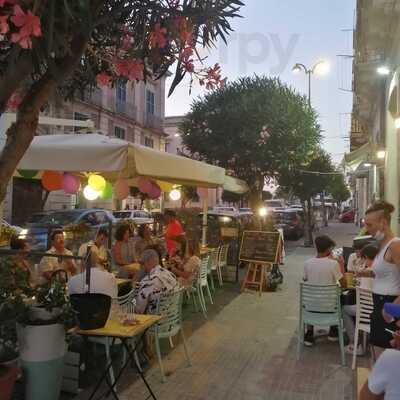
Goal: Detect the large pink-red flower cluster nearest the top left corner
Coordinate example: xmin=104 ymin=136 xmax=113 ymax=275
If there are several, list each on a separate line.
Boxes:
xmin=11 ymin=5 xmax=42 ymax=49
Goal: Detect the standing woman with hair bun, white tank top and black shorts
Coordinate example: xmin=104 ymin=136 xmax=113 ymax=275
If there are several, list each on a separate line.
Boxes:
xmin=356 ymin=201 xmax=400 ymax=358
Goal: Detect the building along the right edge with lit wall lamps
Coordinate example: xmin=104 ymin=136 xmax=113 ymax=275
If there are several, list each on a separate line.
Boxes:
xmin=344 ymin=0 xmax=400 ymax=233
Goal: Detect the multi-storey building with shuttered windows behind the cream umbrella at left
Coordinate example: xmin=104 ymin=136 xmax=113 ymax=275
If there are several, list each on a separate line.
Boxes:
xmin=4 ymin=78 xmax=168 ymax=223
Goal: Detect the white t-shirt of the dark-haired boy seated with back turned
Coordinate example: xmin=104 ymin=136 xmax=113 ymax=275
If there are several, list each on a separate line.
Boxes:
xmin=303 ymin=257 xmax=343 ymax=285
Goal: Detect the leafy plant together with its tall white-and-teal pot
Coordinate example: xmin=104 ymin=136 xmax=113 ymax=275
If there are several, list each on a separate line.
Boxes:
xmin=17 ymin=280 xmax=75 ymax=400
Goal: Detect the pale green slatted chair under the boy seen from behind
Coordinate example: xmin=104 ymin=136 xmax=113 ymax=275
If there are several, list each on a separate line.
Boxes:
xmin=297 ymin=283 xmax=346 ymax=365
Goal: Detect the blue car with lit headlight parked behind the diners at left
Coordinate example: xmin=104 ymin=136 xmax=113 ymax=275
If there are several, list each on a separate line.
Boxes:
xmin=19 ymin=208 xmax=115 ymax=250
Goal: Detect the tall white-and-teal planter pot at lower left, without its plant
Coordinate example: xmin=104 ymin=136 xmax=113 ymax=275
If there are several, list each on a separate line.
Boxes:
xmin=17 ymin=324 xmax=66 ymax=400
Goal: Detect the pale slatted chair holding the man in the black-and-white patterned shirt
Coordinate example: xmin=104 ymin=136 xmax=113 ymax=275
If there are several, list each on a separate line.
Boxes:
xmin=149 ymin=288 xmax=192 ymax=382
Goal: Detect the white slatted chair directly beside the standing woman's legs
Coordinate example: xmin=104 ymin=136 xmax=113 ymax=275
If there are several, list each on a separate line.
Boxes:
xmin=351 ymin=288 xmax=374 ymax=369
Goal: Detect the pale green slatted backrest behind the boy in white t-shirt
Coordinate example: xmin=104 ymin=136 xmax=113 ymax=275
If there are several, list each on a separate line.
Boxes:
xmin=300 ymin=283 xmax=341 ymax=315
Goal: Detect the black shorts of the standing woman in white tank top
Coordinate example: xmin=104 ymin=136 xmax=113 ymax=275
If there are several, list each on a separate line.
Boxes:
xmin=370 ymin=293 xmax=398 ymax=349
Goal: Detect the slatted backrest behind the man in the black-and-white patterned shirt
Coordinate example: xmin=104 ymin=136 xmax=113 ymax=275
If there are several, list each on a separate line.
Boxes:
xmin=152 ymin=288 xmax=183 ymax=338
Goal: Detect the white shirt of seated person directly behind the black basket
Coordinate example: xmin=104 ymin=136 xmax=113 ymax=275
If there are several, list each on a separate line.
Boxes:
xmin=68 ymin=268 xmax=118 ymax=299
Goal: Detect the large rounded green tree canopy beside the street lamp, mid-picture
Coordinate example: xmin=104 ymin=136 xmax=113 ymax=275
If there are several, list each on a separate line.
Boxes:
xmin=181 ymin=76 xmax=320 ymax=197
